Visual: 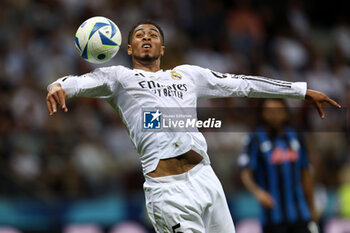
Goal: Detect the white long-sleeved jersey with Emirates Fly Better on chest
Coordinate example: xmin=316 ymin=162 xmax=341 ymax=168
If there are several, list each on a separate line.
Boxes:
xmin=51 ymin=65 xmax=306 ymax=174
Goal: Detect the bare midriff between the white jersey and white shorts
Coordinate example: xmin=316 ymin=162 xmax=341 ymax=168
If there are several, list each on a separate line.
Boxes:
xmin=147 ymin=150 xmax=203 ymax=178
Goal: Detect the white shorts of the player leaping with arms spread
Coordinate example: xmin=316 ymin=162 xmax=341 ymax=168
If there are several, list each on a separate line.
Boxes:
xmin=144 ymin=163 xmax=235 ymax=233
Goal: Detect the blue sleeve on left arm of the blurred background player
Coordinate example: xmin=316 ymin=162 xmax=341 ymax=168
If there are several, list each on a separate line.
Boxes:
xmin=238 ymin=133 xmax=259 ymax=171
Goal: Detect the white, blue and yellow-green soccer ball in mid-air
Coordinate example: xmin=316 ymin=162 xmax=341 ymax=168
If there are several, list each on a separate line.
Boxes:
xmin=75 ymin=16 xmax=122 ymax=63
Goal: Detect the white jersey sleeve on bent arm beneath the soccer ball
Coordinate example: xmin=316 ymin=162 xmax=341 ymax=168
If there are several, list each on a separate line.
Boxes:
xmin=47 ymin=67 xmax=120 ymax=98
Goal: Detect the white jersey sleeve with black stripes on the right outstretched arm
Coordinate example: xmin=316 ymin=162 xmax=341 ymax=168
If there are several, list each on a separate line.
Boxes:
xmin=192 ymin=66 xmax=307 ymax=99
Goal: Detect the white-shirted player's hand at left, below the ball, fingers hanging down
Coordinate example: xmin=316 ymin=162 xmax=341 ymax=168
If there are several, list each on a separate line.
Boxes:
xmin=46 ymin=83 xmax=68 ymax=116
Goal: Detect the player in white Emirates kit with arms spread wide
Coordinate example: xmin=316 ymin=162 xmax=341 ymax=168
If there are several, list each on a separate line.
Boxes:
xmin=46 ymin=21 xmax=339 ymax=233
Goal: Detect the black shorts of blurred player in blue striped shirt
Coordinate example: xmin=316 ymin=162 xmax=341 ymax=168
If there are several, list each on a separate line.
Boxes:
xmin=263 ymin=222 xmax=318 ymax=233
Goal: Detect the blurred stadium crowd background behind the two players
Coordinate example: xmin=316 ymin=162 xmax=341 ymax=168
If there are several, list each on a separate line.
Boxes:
xmin=0 ymin=0 xmax=350 ymax=233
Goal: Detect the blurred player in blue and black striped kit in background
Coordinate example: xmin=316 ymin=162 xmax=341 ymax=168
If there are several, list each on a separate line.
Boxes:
xmin=239 ymin=99 xmax=317 ymax=233
